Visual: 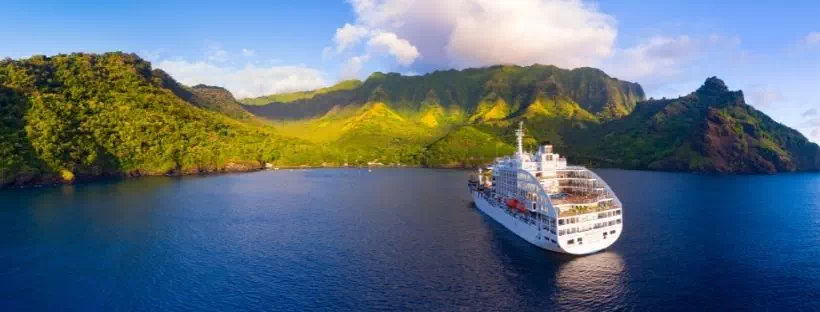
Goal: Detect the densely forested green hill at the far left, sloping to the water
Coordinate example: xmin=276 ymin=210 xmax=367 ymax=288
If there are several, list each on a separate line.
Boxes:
xmin=0 ymin=53 xmax=308 ymax=187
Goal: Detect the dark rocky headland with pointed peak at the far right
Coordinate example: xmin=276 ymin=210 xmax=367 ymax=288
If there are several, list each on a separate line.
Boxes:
xmin=576 ymin=77 xmax=820 ymax=173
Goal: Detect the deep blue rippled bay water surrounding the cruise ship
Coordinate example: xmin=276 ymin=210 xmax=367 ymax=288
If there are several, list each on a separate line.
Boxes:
xmin=0 ymin=169 xmax=820 ymax=311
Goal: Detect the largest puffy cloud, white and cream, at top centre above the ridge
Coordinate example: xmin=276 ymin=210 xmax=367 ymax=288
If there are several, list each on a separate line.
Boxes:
xmin=334 ymin=0 xmax=617 ymax=67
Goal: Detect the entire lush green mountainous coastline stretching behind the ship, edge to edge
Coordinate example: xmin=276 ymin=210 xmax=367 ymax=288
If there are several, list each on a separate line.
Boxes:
xmin=0 ymin=53 xmax=820 ymax=187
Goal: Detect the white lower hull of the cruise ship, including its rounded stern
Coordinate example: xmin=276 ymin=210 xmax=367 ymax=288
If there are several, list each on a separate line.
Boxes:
xmin=470 ymin=191 xmax=622 ymax=255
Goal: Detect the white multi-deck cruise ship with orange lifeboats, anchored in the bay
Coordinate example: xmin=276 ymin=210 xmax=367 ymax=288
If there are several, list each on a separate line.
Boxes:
xmin=468 ymin=123 xmax=623 ymax=255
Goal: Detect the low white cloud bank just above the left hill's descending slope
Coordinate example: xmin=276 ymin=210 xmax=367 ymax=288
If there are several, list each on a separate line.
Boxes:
xmin=157 ymin=59 xmax=327 ymax=98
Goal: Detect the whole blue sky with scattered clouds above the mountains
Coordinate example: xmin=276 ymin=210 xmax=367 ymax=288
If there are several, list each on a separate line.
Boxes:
xmin=0 ymin=0 xmax=820 ymax=142
